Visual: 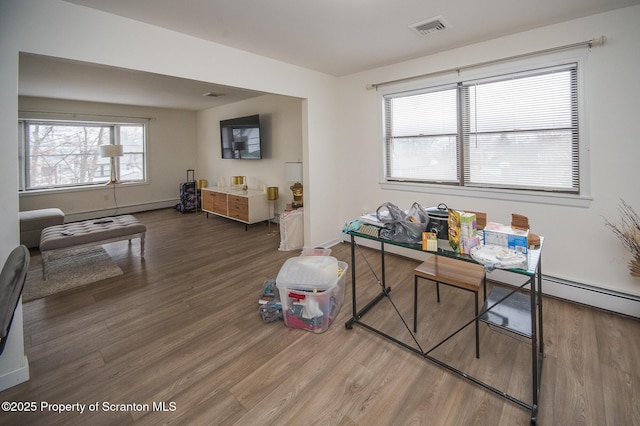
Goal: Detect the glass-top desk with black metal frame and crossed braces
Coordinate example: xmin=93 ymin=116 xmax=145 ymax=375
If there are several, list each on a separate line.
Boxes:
xmin=345 ymin=231 xmax=544 ymax=424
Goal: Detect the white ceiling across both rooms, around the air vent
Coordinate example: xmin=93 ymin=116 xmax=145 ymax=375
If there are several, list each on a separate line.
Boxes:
xmin=20 ymin=0 xmax=640 ymax=109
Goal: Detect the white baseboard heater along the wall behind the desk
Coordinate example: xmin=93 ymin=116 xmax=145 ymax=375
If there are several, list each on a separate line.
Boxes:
xmin=342 ymin=235 xmax=640 ymax=318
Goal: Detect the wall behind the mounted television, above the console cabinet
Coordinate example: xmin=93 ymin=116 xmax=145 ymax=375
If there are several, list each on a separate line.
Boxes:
xmin=196 ymin=95 xmax=302 ymax=212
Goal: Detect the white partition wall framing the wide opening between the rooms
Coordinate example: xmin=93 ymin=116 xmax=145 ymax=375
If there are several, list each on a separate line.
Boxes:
xmin=0 ymin=0 xmax=337 ymax=386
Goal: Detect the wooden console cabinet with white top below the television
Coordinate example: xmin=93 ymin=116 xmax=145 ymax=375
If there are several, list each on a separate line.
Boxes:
xmin=202 ymin=187 xmax=271 ymax=224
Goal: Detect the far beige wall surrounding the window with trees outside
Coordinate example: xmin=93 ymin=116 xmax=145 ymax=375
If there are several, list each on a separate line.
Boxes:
xmin=18 ymin=97 xmax=197 ymax=221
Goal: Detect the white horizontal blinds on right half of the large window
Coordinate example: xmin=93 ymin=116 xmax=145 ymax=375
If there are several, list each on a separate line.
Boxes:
xmin=461 ymin=66 xmax=579 ymax=192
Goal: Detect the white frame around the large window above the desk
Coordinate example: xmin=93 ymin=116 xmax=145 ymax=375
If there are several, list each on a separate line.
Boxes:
xmin=377 ymin=51 xmax=592 ymax=207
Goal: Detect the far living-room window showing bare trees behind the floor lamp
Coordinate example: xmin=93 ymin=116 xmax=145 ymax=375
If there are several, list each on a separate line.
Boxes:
xmin=18 ymin=120 xmax=146 ymax=191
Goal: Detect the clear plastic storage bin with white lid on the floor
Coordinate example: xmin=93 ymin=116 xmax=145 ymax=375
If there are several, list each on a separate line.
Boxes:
xmin=276 ymin=256 xmax=348 ymax=333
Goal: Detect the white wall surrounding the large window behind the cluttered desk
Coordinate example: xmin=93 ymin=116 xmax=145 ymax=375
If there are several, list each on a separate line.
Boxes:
xmin=339 ymin=6 xmax=640 ymax=316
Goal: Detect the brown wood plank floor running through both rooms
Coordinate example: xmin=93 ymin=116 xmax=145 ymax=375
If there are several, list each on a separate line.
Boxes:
xmin=0 ymin=209 xmax=640 ymax=425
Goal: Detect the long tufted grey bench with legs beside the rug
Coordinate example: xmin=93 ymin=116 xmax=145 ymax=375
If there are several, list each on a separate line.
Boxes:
xmin=40 ymin=215 xmax=147 ymax=280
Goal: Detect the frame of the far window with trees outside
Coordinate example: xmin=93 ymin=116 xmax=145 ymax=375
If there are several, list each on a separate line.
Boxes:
xmin=18 ymin=113 xmax=149 ymax=191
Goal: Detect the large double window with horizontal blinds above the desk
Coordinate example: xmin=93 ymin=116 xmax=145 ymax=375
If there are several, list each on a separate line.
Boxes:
xmin=382 ymin=63 xmax=581 ymax=194
